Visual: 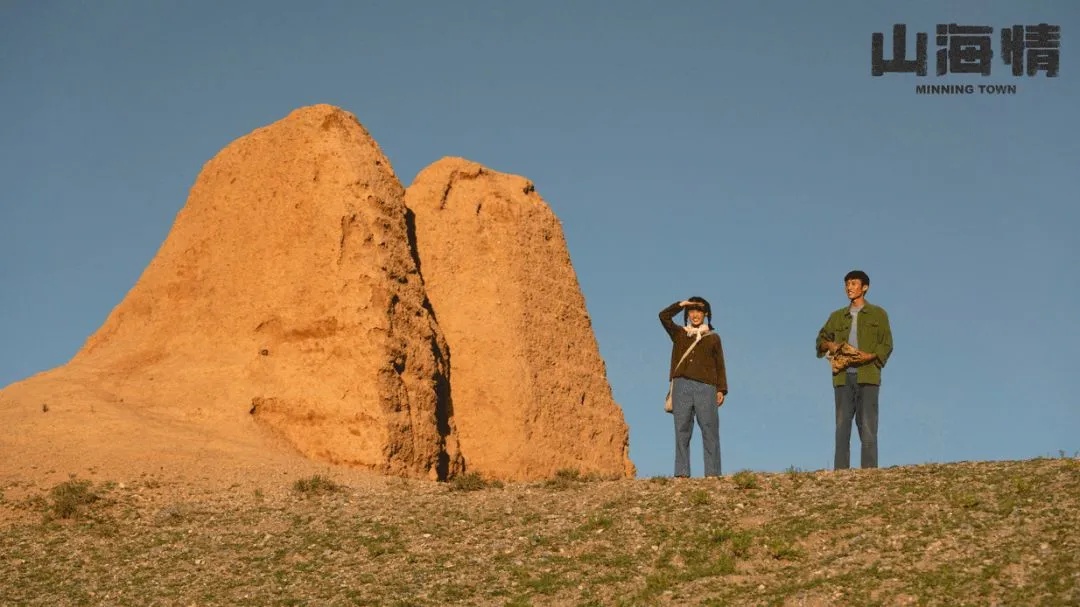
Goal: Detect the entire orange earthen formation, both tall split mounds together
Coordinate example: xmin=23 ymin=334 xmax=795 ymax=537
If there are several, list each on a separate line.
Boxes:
xmin=0 ymin=105 xmax=634 ymax=480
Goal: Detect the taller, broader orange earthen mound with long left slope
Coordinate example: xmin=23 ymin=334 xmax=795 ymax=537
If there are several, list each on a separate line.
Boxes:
xmin=2 ymin=105 xmax=461 ymax=478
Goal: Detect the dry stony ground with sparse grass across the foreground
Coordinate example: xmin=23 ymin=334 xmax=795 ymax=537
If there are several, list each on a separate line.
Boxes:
xmin=0 ymin=457 xmax=1080 ymax=606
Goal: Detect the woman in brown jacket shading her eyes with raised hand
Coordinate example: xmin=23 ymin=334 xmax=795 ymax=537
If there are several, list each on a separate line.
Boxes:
xmin=660 ymin=297 xmax=728 ymax=477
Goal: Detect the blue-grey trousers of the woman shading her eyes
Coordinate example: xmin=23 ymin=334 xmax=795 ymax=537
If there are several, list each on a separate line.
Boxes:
xmin=672 ymin=377 xmax=720 ymax=476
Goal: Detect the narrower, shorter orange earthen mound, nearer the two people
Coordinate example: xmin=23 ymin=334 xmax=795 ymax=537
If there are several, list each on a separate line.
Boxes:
xmin=405 ymin=158 xmax=634 ymax=481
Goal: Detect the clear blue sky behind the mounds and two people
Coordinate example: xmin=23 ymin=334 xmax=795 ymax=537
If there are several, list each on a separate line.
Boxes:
xmin=0 ymin=0 xmax=1080 ymax=476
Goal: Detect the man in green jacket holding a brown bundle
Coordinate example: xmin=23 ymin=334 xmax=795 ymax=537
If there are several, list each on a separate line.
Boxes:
xmin=815 ymin=270 xmax=892 ymax=470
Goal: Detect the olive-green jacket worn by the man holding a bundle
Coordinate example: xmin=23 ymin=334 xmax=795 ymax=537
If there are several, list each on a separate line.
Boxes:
xmin=814 ymin=302 xmax=892 ymax=386
